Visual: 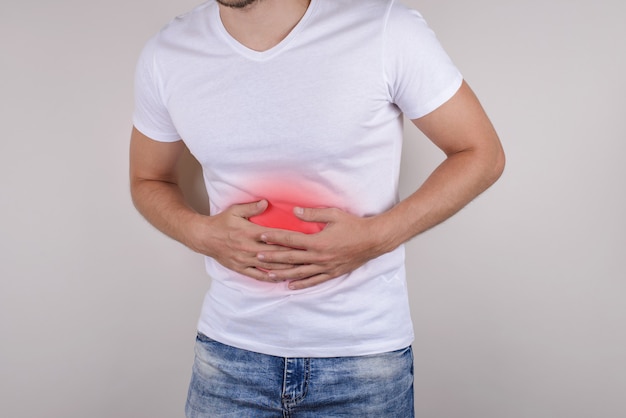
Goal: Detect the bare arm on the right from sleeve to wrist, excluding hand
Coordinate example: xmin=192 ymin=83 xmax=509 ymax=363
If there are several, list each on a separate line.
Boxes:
xmin=372 ymin=82 xmax=505 ymax=244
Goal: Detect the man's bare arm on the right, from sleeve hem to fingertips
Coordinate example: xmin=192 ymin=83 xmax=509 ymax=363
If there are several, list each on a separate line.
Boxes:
xmin=258 ymin=83 xmax=504 ymax=289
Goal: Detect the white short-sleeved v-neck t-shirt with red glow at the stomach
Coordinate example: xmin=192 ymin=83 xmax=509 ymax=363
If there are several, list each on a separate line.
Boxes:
xmin=134 ymin=0 xmax=462 ymax=357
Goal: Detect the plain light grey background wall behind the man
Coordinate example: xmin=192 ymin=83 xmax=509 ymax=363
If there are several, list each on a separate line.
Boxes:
xmin=0 ymin=0 xmax=626 ymax=418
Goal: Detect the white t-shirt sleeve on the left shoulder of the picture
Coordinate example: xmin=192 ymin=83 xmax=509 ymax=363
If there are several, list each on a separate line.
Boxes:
xmin=133 ymin=38 xmax=181 ymax=142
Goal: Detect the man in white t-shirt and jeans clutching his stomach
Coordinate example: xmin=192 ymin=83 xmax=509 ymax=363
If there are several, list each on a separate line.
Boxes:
xmin=130 ymin=0 xmax=504 ymax=418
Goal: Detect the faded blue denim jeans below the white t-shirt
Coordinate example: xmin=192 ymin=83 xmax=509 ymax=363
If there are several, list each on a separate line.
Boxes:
xmin=185 ymin=334 xmax=414 ymax=418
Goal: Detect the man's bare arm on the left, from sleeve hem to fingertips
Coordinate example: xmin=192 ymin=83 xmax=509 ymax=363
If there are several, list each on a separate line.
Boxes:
xmin=130 ymin=128 xmax=291 ymax=281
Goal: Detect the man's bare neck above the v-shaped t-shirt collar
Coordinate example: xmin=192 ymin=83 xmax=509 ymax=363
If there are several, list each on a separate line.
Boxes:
xmin=218 ymin=0 xmax=310 ymax=51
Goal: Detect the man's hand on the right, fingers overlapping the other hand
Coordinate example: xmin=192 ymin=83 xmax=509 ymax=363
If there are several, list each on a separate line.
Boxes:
xmin=257 ymin=208 xmax=394 ymax=290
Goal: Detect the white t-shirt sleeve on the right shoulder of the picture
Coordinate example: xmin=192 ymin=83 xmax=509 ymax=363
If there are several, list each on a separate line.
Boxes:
xmin=384 ymin=2 xmax=463 ymax=119
